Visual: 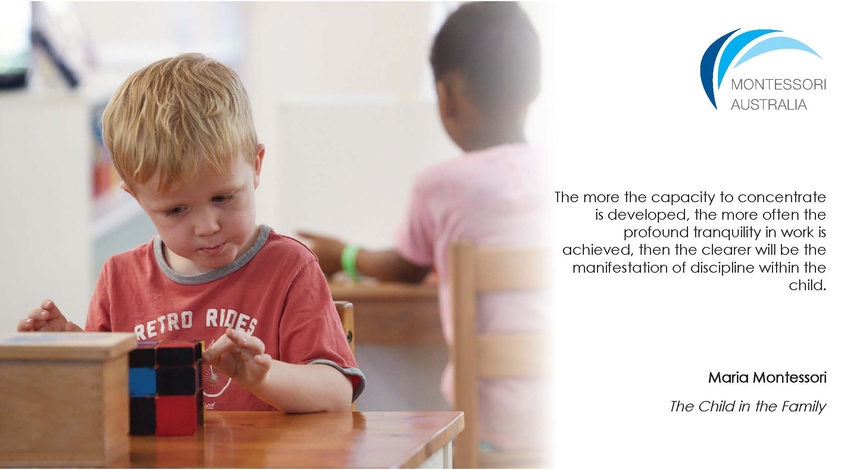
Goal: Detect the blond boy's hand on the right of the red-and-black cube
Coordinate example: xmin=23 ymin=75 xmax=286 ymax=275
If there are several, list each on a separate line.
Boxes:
xmin=204 ymin=328 xmax=272 ymax=391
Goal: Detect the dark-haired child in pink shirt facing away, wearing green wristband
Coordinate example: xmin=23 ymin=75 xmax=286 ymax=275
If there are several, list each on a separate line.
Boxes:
xmin=299 ymin=2 xmax=548 ymax=450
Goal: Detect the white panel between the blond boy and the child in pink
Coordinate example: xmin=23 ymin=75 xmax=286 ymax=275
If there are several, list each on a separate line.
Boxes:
xmin=272 ymin=99 xmax=461 ymax=248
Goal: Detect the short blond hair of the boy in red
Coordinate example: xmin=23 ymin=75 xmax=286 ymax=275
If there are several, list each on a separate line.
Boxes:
xmin=103 ymin=54 xmax=257 ymax=191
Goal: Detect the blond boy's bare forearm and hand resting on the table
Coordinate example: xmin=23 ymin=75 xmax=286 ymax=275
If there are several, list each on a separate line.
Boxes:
xmin=204 ymin=328 xmax=352 ymax=413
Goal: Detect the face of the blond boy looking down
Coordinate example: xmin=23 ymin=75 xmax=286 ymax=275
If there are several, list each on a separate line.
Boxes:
xmin=124 ymin=144 xmax=265 ymax=274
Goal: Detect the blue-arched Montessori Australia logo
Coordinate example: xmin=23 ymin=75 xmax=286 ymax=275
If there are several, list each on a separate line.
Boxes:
xmin=700 ymin=29 xmax=826 ymax=111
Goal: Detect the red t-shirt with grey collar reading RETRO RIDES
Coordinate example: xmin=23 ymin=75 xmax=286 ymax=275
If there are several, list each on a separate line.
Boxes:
xmin=85 ymin=226 xmax=366 ymax=411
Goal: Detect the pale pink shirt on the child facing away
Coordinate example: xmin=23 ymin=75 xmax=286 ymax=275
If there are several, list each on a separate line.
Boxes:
xmin=396 ymin=144 xmax=550 ymax=450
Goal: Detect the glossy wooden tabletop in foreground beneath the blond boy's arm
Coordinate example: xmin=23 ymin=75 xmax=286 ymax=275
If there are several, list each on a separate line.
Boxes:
xmin=112 ymin=411 xmax=464 ymax=468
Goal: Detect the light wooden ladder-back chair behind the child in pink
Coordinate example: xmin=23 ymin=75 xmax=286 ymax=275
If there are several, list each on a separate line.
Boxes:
xmin=449 ymin=241 xmax=551 ymax=468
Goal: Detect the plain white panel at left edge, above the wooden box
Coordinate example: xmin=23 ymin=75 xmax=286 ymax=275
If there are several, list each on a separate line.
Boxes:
xmin=0 ymin=93 xmax=93 ymax=334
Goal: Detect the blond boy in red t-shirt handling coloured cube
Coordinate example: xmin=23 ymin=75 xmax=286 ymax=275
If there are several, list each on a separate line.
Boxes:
xmin=18 ymin=54 xmax=365 ymax=413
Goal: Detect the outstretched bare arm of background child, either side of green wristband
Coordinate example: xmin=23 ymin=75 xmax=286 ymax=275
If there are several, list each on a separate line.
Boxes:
xmin=298 ymin=232 xmax=431 ymax=283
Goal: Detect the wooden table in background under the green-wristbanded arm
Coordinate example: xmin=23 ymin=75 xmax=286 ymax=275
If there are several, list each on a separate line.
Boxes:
xmin=330 ymin=281 xmax=444 ymax=344
